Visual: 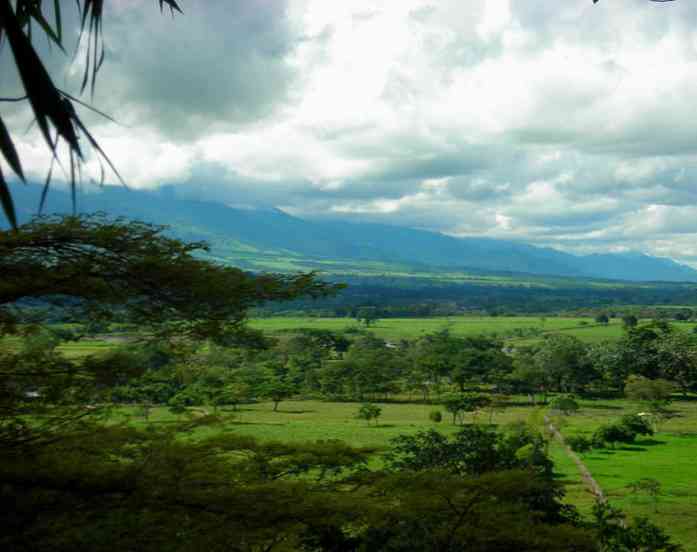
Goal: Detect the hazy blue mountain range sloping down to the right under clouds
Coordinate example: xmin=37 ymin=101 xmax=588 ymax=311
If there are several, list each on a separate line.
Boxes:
xmin=13 ymin=185 xmax=697 ymax=282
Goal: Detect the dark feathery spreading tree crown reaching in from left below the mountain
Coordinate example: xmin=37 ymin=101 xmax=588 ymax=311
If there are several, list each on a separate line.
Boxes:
xmin=0 ymin=215 xmax=338 ymax=344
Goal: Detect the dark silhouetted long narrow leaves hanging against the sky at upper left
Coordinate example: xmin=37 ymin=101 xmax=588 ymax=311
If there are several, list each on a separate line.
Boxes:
xmin=0 ymin=0 xmax=181 ymax=228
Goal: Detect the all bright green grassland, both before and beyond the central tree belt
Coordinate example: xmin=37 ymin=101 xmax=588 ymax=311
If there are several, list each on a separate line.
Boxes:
xmin=3 ymin=316 xmax=697 ymax=552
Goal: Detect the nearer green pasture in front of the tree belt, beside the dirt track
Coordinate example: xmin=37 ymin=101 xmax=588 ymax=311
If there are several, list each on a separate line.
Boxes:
xmin=114 ymin=394 xmax=697 ymax=551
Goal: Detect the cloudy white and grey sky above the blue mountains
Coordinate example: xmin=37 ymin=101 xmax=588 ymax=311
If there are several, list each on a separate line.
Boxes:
xmin=6 ymin=0 xmax=697 ymax=267
